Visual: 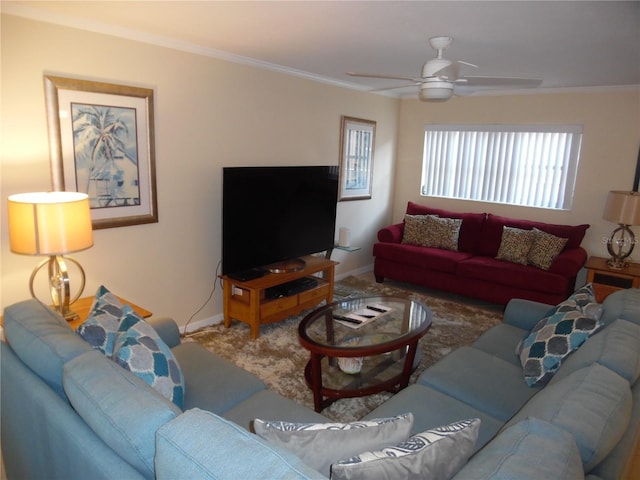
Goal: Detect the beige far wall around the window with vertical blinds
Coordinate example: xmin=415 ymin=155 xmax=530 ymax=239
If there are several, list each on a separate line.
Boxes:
xmin=393 ymin=90 xmax=640 ymax=260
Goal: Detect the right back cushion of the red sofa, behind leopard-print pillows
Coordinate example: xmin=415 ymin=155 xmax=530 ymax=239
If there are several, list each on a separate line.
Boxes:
xmin=477 ymin=213 xmax=589 ymax=258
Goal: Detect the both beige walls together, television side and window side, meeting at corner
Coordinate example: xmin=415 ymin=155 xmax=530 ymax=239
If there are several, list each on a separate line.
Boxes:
xmin=0 ymin=15 xmax=640 ymax=324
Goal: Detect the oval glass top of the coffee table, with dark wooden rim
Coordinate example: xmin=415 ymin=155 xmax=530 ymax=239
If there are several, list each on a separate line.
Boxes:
xmin=299 ymin=296 xmax=431 ymax=356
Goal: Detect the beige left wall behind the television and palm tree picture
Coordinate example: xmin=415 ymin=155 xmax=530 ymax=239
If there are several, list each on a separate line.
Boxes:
xmin=0 ymin=15 xmax=399 ymax=330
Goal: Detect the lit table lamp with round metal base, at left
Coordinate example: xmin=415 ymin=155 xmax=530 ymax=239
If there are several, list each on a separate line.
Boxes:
xmin=8 ymin=192 xmax=93 ymax=320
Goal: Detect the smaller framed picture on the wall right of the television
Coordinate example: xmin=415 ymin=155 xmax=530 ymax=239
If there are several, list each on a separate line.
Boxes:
xmin=338 ymin=115 xmax=376 ymax=202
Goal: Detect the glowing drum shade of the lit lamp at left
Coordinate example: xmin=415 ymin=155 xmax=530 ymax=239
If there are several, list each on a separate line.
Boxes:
xmin=8 ymin=192 xmax=93 ymax=256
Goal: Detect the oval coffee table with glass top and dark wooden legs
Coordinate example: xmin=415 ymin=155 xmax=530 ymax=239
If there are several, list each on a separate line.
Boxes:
xmin=298 ymin=296 xmax=431 ymax=412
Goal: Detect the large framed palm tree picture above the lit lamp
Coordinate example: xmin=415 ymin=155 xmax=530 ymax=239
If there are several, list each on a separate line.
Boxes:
xmin=44 ymin=75 xmax=158 ymax=229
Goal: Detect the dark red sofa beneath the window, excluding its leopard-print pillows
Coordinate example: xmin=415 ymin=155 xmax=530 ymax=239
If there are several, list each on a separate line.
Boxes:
xmin=373 ymin=202 xmax=589 ymax=305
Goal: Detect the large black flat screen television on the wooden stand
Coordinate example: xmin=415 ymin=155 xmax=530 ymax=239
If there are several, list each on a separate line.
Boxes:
xmin=222 ymin=166 xmax=338 ymax=280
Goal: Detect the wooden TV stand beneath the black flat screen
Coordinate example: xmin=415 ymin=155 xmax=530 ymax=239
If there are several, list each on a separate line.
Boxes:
xmin=221 ymin=256 xmax=338 ymax=338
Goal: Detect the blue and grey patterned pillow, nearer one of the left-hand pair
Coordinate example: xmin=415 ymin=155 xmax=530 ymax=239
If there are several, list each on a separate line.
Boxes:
xmin=113 ymin=305 xmax=184 ymax=408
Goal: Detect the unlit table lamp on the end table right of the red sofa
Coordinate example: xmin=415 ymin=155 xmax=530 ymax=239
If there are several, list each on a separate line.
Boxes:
xmin=603 ymin=191 xmax=640 ymax=269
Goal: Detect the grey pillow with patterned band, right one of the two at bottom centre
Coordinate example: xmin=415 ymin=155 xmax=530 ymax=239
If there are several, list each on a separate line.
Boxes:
xmin=331 ymin=418 xmax=480 ymax=480
